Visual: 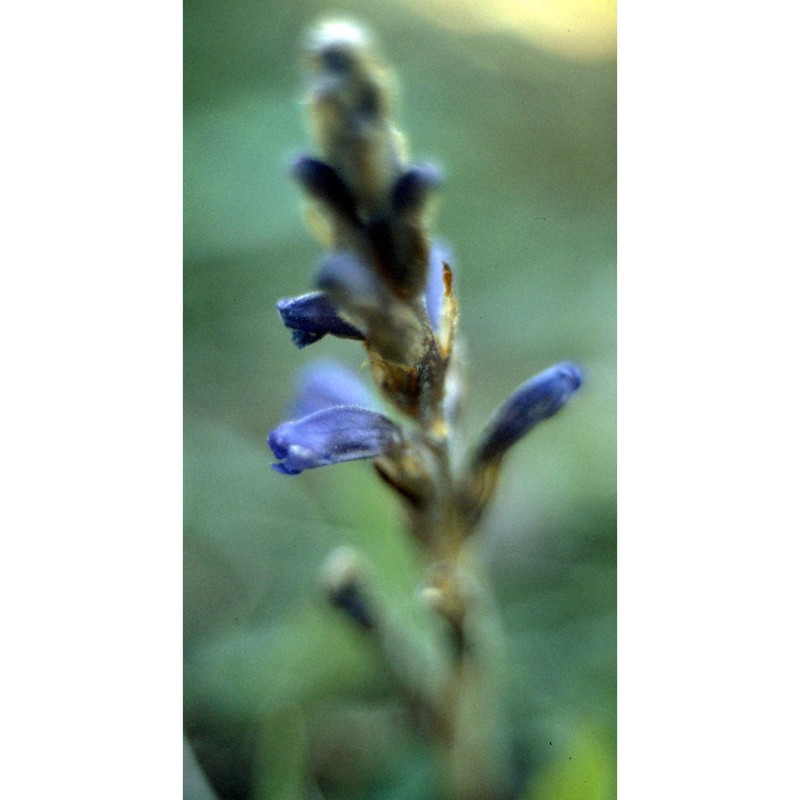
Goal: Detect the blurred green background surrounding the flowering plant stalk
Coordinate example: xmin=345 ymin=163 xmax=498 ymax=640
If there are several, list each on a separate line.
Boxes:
xmin=184 ymin=0 xmax=616 ymax=800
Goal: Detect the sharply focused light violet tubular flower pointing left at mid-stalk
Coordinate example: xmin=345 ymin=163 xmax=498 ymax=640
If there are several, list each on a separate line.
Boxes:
xmin=268 ymin=406 xmax=403 ymax=475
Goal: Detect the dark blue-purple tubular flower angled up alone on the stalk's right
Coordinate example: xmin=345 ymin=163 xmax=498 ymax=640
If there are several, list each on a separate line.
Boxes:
xmin=474 ymin=361 xmax=582 ymax=464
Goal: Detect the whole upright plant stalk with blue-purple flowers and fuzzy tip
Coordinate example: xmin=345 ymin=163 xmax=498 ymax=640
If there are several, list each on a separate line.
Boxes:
xmin=269 ymin=22 xmax=581 ymax=800
